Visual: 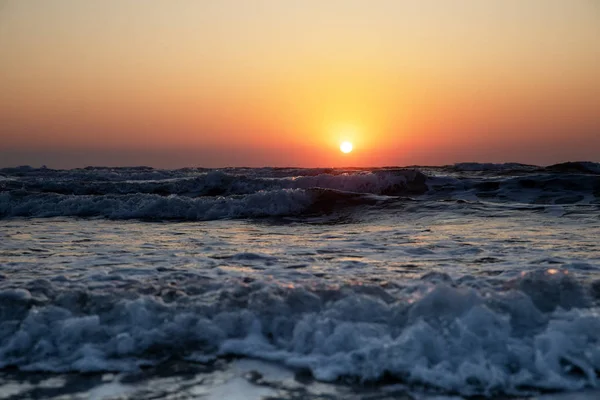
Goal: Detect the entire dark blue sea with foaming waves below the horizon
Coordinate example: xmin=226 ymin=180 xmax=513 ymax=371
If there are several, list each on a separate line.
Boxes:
xmin=0 ymin=162 xmax=600 ymax=399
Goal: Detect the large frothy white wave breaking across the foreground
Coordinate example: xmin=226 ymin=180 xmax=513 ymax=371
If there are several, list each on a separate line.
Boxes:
xmin=0 ymin=270 xmax=600 ymax=395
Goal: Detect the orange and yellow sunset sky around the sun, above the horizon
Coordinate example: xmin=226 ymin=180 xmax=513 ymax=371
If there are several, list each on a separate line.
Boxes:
xmin=0 ymin=0 xmax=600 ymax=168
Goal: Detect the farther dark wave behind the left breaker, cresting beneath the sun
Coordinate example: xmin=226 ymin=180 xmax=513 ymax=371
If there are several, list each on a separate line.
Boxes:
xmin=0 ymin=170 xmax=427 ymax=197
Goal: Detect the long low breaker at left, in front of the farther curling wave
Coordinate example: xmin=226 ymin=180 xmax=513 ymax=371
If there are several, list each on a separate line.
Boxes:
xmin=0 ymin=188 xmax=398 ymax=221
